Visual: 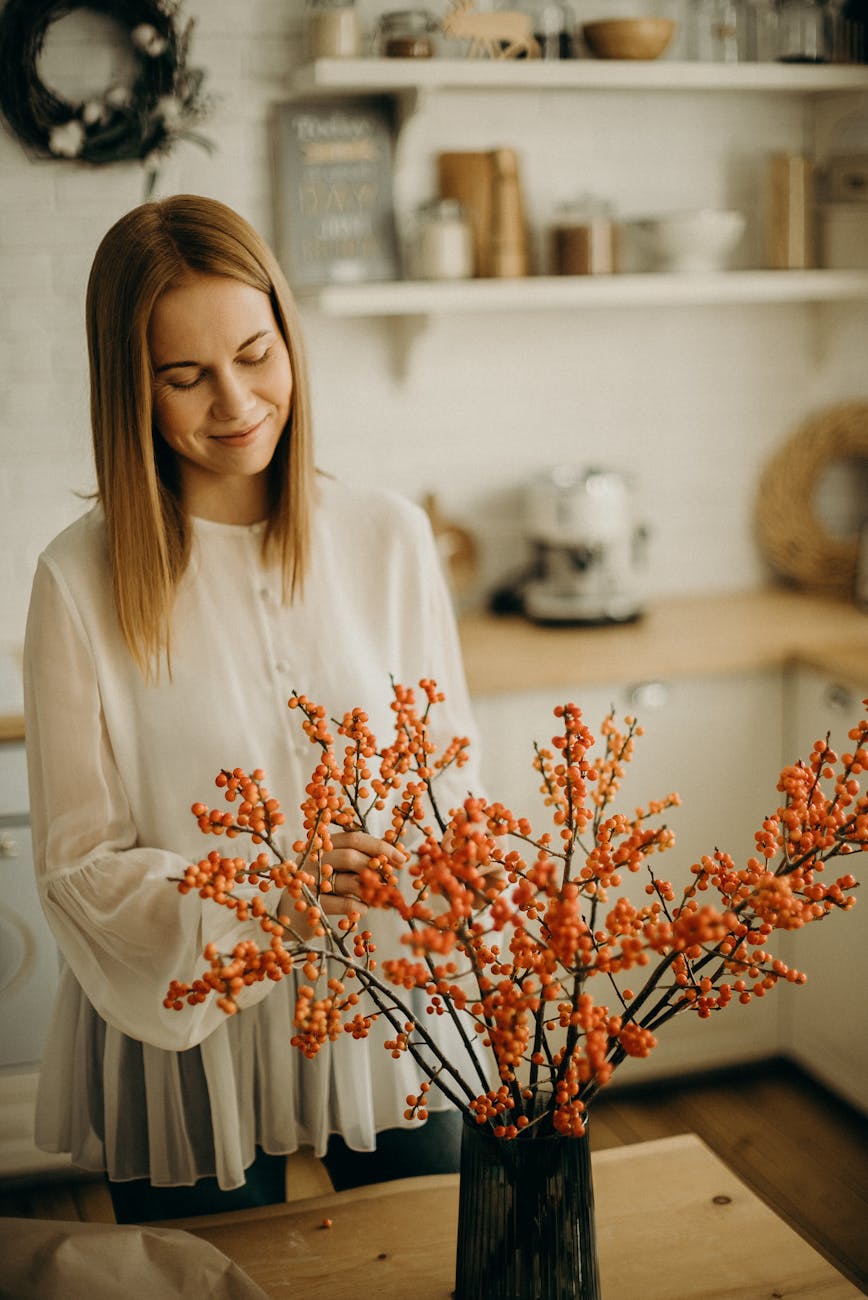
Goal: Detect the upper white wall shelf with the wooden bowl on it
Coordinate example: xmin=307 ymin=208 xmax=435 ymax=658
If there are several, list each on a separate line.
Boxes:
xmin=292 ymin=57 xmax=868 ymax=95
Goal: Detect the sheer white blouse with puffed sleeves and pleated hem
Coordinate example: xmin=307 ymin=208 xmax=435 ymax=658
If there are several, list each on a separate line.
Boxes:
xmin=25 ymin=480 xmax=488 ymax=1188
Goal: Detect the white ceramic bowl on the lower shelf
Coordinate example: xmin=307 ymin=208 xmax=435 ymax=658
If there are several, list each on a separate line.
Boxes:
xmin=630 ymin=208 xmax=745 ymax=270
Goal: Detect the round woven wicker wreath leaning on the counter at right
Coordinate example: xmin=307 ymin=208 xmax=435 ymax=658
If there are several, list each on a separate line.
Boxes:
xmin=758 ymin=402 xmax=868 ymax=597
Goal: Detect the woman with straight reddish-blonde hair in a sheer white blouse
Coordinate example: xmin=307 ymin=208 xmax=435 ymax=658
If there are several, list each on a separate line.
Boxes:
xmin=25 ymin=189 xmax=476 ymax=1222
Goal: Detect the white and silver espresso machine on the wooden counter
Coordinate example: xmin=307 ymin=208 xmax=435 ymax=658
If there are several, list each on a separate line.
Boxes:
xmin=516 ymin=465 xmax=647 ymax=625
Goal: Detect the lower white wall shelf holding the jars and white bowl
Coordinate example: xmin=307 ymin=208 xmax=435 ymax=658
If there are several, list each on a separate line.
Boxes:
xmin=299 ymin=270 xmax=868 ymax=316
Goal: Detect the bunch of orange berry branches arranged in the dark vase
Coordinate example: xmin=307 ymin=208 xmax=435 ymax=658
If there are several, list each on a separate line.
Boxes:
xmin=164 ymin=680 xmax=868 ymax=1139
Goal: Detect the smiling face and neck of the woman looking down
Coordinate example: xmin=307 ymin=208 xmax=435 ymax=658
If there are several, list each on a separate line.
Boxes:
xmin=148 ymin=273 xmax=292 ymax=524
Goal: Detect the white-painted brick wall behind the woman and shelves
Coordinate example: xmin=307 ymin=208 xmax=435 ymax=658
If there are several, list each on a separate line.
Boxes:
xmin=0 ymin=0 xmax=868 ymax=645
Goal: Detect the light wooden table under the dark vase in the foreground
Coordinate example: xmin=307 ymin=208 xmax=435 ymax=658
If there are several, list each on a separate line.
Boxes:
xmin=162 ymin=1134 xmax=862 ymax=1300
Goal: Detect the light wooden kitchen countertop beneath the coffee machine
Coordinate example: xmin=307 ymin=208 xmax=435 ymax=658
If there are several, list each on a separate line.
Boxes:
xmin=459 ymin=588 xmax=868 ymax=696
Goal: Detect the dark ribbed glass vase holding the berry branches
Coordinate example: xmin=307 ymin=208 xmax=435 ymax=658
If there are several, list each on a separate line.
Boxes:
xmin=455 ymin=1121 xmax=600 ymax=1300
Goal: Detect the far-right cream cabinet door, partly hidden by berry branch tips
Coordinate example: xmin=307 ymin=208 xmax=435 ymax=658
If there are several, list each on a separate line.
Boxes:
xmin=781 ymin=668 xmax=868 ymax=1113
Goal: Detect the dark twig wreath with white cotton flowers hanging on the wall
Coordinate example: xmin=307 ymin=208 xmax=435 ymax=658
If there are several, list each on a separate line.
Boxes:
xmin=0 ymin=0 xmax=208 ymax=164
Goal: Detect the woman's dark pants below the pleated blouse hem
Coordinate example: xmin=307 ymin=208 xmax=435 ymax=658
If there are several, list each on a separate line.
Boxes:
xmin=108 ymin=1110 xmax=461 ymax=1223
